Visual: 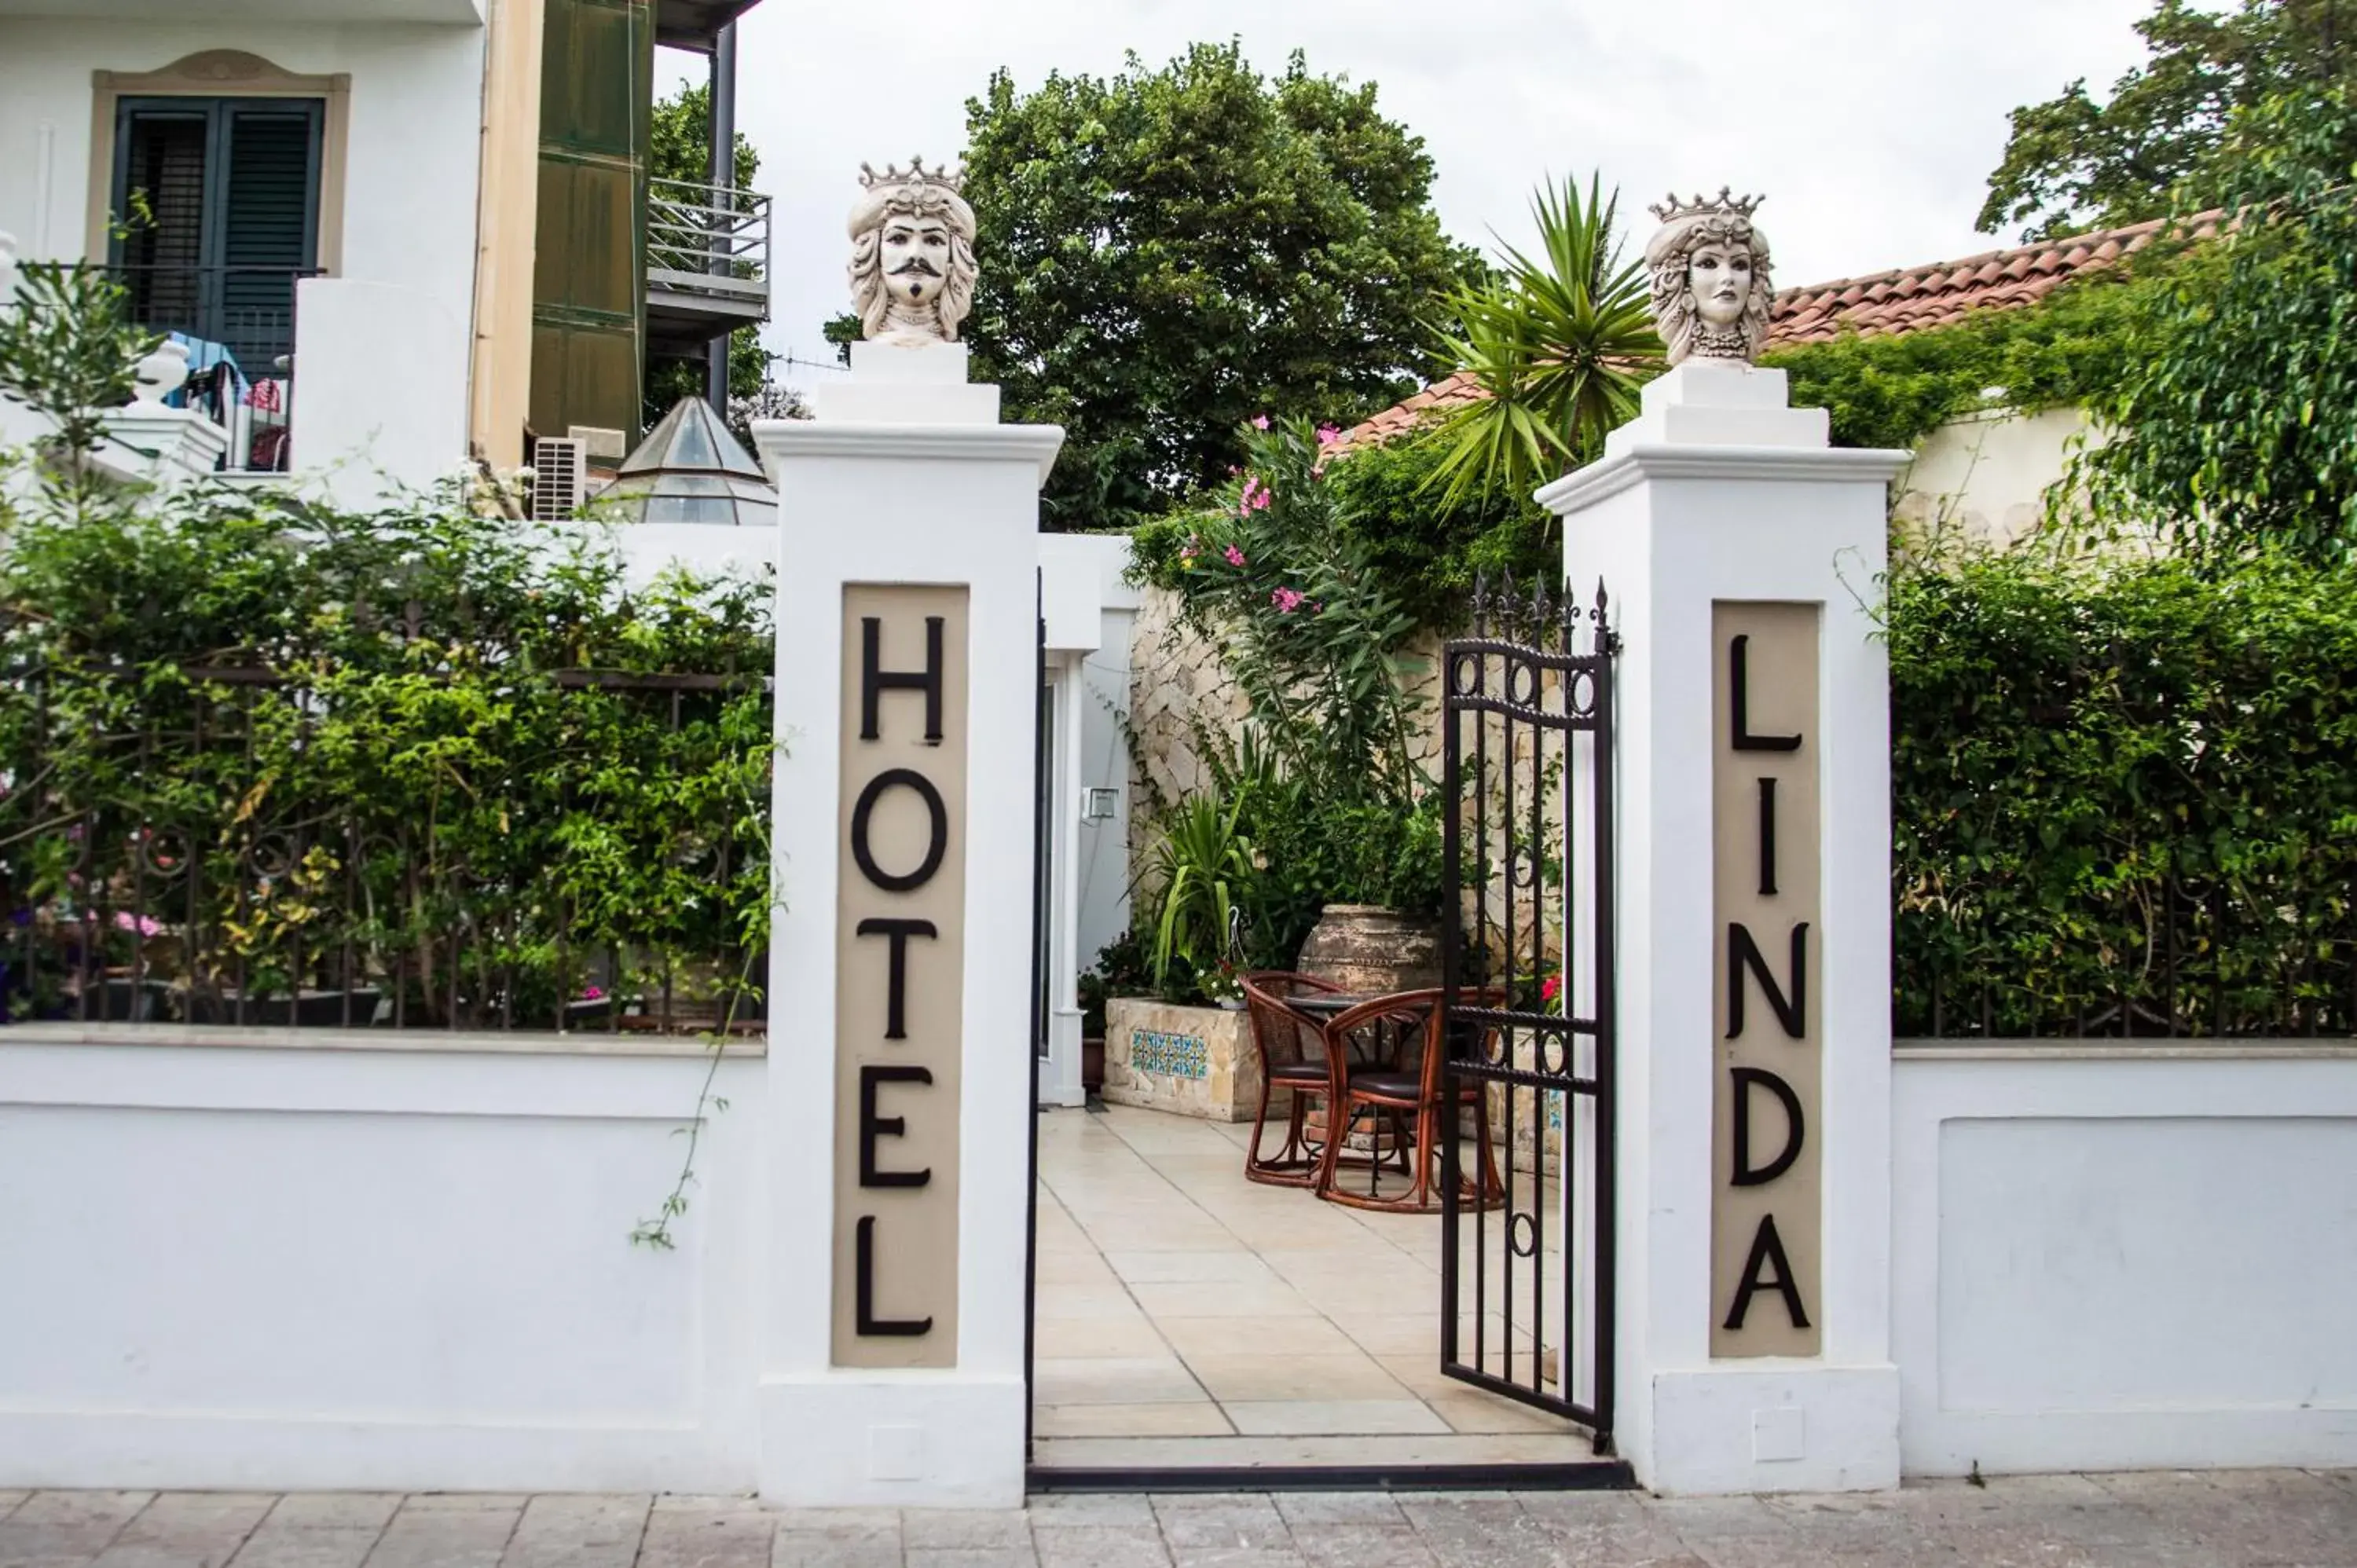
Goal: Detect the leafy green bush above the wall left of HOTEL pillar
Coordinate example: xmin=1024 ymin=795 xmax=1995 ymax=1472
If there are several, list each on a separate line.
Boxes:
xmin=0 ymin=490 xmax=771 ymax=1026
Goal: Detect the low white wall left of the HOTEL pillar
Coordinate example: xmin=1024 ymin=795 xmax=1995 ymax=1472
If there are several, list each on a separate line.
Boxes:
xmin=0 ymin=1026 xmax=764 ymax=1493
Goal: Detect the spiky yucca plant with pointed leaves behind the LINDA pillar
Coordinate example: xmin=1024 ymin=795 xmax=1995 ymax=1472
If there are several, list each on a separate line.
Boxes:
xmin=1428 ymin=177 xmax=1662 ymax=504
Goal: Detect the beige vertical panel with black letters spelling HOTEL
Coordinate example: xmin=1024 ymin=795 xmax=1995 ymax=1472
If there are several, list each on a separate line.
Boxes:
xmin=834 ymin=584 xmax=969 ymax=1368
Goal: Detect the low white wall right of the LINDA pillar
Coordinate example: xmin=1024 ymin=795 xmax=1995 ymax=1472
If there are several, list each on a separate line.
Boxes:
xmin=1890 ymin=1045 xmax=2357 ymax=1476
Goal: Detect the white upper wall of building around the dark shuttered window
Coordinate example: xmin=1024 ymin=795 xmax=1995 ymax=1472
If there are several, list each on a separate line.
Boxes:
xmin=0 ymin=19 xmax=486 ymax=497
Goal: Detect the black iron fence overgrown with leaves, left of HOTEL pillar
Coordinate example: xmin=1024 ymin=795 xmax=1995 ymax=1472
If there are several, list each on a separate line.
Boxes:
xmin=0 ymin=667 xmax=771 ymax=1033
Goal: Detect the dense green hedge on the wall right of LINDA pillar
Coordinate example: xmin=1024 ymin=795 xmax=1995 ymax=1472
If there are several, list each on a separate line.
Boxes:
xmin=1888 ymin=554 xmax=2357 ymax=1038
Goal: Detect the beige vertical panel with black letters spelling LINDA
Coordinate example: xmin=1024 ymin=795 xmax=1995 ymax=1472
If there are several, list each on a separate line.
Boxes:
xmin=1711 ymin=603 xmax=1824 ymax=1356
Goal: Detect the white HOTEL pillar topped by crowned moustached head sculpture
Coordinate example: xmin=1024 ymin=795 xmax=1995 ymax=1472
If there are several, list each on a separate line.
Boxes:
xmin=754 ymin=165 xmax=1063 ymax=1507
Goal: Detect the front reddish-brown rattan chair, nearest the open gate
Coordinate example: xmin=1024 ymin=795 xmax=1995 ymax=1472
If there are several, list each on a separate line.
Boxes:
xmin=1318 ymin=991 xmax=1506 ymax=1214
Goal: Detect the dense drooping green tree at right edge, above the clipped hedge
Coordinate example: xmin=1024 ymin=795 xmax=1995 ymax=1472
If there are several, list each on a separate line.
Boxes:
xmin=2072 ymin=87 xmax=2357 ymax=561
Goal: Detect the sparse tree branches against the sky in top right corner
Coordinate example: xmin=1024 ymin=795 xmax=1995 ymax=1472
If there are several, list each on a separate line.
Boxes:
xmin=1980 ymin=0 xmax=2357 ymax=240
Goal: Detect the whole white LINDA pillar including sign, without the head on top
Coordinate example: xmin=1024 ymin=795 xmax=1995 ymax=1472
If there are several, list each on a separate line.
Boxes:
xmin=1539 ymin=358 xmax=1907 ymax=1493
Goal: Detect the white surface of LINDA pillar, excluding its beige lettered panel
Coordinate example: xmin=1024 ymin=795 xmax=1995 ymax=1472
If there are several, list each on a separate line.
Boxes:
xmin=1539 ymin=361 xmax=1907 ymax=1493
